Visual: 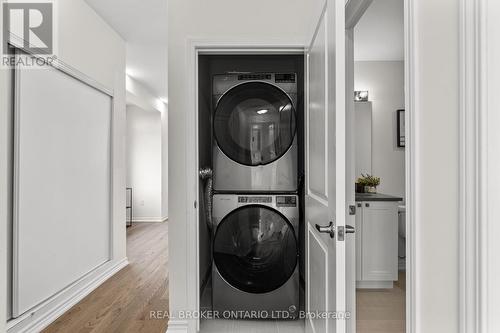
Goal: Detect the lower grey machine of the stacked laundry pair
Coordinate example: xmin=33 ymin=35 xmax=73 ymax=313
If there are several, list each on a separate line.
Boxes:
xmin=212 ymin=194 xmax=299 ymax=319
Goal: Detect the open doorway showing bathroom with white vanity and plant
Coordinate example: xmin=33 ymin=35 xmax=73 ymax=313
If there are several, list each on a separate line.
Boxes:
xmin=346 ymin=0 xmax=407 ymax=333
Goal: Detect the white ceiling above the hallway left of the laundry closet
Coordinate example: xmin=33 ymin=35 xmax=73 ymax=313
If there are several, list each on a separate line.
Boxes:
xmin=85 ymin=0 xmax=167 ymax=98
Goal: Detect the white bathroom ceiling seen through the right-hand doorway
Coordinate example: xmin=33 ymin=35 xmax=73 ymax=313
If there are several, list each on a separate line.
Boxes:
xmin=354 ymin=0 xmax=404 ymax=61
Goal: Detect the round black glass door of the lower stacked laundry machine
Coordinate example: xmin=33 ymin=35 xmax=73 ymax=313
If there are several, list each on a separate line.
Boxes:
xmin=213 ymin=205 xmax=298 ymax=293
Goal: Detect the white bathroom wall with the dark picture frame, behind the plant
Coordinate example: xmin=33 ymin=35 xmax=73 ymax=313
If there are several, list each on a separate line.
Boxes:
xmin=354 ymin=60 xmax=405 ymax=198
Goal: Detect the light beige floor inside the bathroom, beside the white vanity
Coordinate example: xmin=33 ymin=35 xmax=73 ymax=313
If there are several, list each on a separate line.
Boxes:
xmin=356 ymin=272 xmax=406 ymax=333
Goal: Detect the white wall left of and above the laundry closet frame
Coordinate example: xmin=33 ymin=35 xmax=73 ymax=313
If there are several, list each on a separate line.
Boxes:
xmin=168 ymin=0 xmax=317 ymax=329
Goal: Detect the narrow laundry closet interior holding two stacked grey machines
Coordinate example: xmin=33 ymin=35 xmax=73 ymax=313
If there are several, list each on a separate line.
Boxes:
xmin=198 ymin=54 xmax=305 ymax=320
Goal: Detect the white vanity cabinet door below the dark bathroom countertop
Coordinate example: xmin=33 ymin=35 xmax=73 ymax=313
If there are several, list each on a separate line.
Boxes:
xmin=361 ymin=202 xmax=398 ymax=281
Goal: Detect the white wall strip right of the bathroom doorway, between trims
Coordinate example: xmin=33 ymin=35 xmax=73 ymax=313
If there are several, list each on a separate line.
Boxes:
xmin=412 ymin=0 xmax=459 ymax=333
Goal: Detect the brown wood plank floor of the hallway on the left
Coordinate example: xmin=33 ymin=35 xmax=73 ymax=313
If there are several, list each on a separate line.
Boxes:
xmin=43 ymin=223 xmax=168 ymax=333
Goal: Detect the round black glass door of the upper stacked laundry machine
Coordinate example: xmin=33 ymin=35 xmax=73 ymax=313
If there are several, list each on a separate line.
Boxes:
xmin=214 ymin=82 xmax=296 ymax=166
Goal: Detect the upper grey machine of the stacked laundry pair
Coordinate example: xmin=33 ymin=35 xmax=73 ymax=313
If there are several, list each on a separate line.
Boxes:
xmin=213 ymin=73 xmax=298 ymax=192
